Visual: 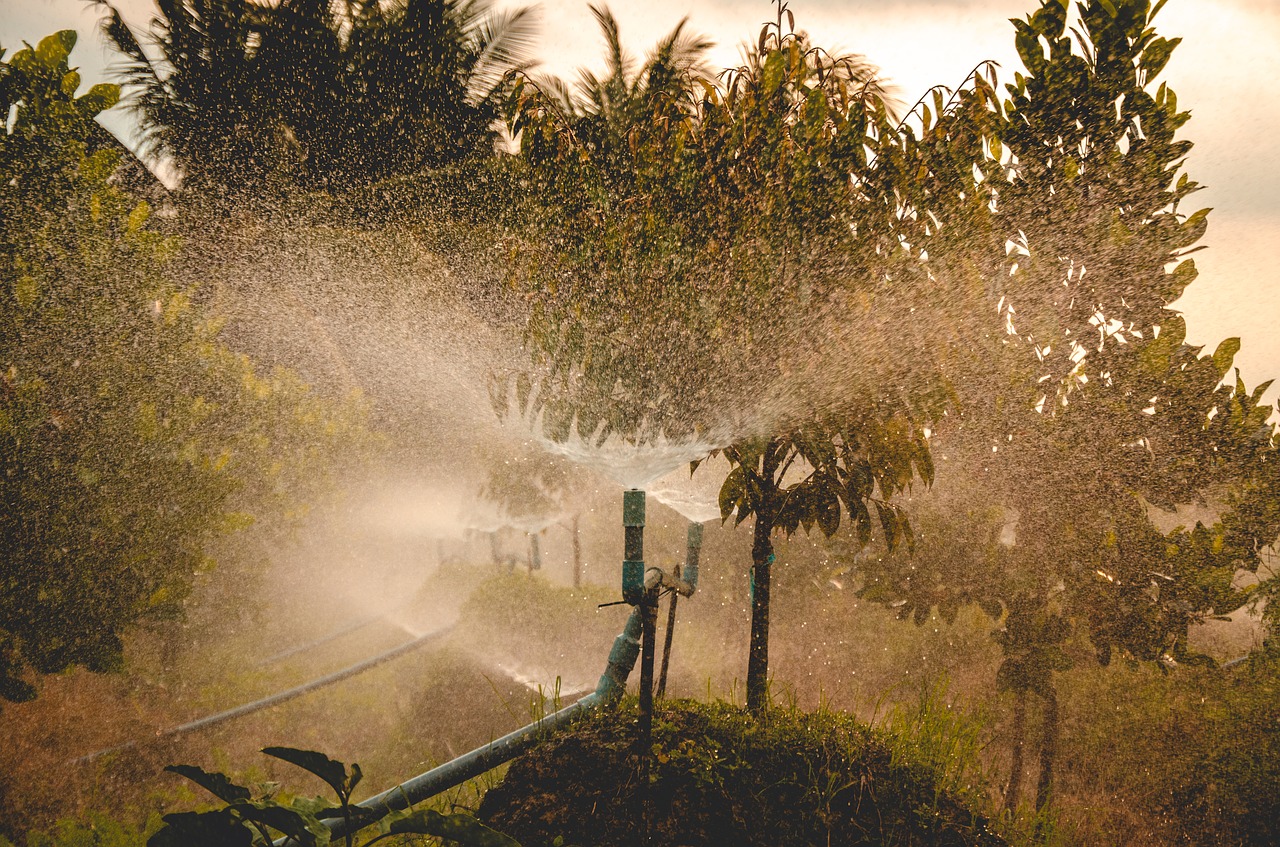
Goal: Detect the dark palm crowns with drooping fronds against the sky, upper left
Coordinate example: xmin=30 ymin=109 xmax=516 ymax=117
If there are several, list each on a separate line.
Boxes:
xmin=94 ymin=0 xmax=532 ymax=205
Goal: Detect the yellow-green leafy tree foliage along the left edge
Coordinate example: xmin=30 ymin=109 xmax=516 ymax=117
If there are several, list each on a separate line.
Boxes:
xmin=0 ymin=32 xmax=361 ymax=700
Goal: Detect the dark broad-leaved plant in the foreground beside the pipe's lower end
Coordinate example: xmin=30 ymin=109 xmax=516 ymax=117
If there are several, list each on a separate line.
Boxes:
xmin=147 ymin=747 xmax=520 ymax=847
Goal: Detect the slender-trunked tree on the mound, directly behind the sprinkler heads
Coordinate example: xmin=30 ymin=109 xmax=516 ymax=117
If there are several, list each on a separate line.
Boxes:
xmin=504 ymin=4 xmax=972 ymax=711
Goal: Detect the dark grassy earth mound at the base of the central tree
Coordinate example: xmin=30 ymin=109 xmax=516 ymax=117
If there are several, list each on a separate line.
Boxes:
xmin=479 ymin=701 xmax=1005 ymax=847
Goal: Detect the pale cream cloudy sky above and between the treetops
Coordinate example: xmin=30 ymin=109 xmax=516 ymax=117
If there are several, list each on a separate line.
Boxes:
xmin=0 ymin=0 xmax=1280 ymax=399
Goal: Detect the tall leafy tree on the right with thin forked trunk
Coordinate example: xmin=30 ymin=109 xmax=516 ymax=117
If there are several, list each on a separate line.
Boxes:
xmin=863 ymin=0 xmax=1280 ymax=805
